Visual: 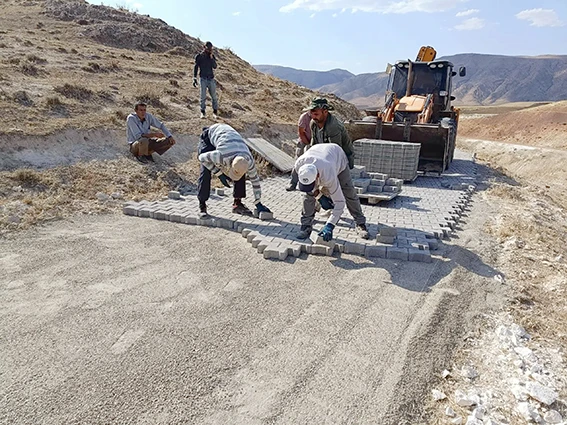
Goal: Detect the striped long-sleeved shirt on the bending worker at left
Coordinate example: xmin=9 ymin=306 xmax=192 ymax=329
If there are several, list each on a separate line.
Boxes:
xmin=199 ymin=124 xmax=262 ymax=203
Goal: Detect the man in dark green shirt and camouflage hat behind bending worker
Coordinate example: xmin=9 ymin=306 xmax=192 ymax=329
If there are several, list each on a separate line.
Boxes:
xmin=306 ymin=97 xmax=354 ymax=169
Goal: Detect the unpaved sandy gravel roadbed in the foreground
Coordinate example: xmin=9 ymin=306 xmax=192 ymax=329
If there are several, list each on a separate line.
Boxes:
xmin=0 ymin=205 xmax=506 ymax=425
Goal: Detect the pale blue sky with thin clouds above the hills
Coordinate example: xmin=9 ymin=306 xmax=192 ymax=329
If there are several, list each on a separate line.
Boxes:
xmin=89 ymin=0 xmax=567 ymax=74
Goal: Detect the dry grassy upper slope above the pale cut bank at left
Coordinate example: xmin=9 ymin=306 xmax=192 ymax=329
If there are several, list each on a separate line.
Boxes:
xmin=0 ymin=0 xmax=358 ymax=134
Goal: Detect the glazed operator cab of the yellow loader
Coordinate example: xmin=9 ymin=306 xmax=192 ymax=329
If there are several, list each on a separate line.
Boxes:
xmin=386 ymin=61 xmax=453 ymax=111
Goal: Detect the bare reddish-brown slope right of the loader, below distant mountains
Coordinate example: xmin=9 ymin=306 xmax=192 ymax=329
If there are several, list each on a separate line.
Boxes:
xmin=459 ymin=101 xmax=567 ymax=149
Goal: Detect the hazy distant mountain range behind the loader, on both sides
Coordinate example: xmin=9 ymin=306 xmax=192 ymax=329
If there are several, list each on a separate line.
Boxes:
xmin=255 ymin=53 xmax=567 ymax=108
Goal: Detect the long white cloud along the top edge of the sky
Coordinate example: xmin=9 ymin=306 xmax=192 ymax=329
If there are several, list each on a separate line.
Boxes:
xmin=280 ymin=0 xmax=468 ymax=13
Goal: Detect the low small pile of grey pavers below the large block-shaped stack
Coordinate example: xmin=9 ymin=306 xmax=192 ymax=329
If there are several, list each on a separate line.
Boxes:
xmin=350 ymin=165 xmax=404 ymax=204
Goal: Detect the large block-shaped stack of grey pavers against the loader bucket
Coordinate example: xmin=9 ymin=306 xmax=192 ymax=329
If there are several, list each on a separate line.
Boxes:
xmin=354 ymin=139 xmax=421 ymax=181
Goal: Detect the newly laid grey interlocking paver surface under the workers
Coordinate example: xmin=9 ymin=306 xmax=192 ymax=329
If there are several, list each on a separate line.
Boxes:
xmin=123 ymin=151 xmax=476 ymax=262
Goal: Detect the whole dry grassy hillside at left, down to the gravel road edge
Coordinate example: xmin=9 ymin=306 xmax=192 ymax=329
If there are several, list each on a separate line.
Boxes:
xmin=0 ymin=0 xmax=360 ymax=232
